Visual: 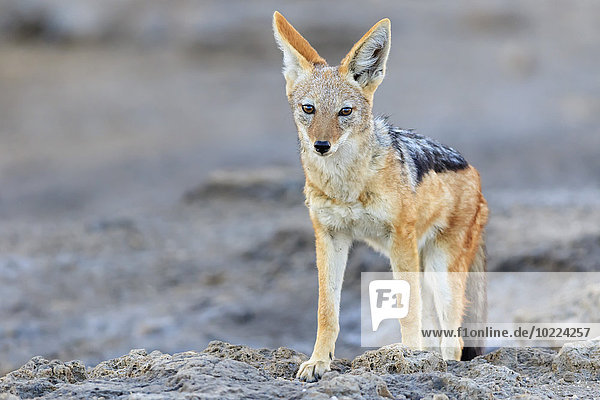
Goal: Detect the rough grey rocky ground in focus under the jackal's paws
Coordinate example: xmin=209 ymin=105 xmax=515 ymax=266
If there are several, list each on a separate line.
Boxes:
xmin=0 ymin=339 xmax=600 ymax=400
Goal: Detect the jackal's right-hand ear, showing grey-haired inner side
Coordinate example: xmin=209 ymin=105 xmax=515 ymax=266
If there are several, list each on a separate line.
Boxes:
xmin=339 ymin=18 xmax=392 ymax=97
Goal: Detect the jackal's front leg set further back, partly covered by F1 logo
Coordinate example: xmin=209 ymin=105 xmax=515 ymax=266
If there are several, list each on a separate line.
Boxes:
xmin=390 ymin=231 xmax=423 ymax=350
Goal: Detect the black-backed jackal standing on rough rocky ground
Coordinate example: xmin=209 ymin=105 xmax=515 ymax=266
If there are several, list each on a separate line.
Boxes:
xmin=273 ymin=12 xmax=488 ymax=381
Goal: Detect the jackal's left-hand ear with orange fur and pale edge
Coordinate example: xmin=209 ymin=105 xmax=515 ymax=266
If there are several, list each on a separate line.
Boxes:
xmin=273 ymin=11 xmax=327 ymax=94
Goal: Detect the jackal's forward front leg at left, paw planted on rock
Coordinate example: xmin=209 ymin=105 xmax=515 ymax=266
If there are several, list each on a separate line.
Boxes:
xmin=297 ymin=227 xmax=351 ymax=382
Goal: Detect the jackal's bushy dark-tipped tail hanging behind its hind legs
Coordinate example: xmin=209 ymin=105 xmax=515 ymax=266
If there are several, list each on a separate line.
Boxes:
xmin=460 ymin=238 xmax=487 ymax=361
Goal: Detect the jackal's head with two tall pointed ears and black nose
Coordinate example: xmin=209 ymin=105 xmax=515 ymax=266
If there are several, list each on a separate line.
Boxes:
xmin=273 ymin=11 xmax=391 ymax=157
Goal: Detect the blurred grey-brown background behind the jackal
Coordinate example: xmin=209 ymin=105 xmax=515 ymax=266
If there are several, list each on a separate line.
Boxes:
xmin=0 ymin=0 xmax=600 ymax=374
